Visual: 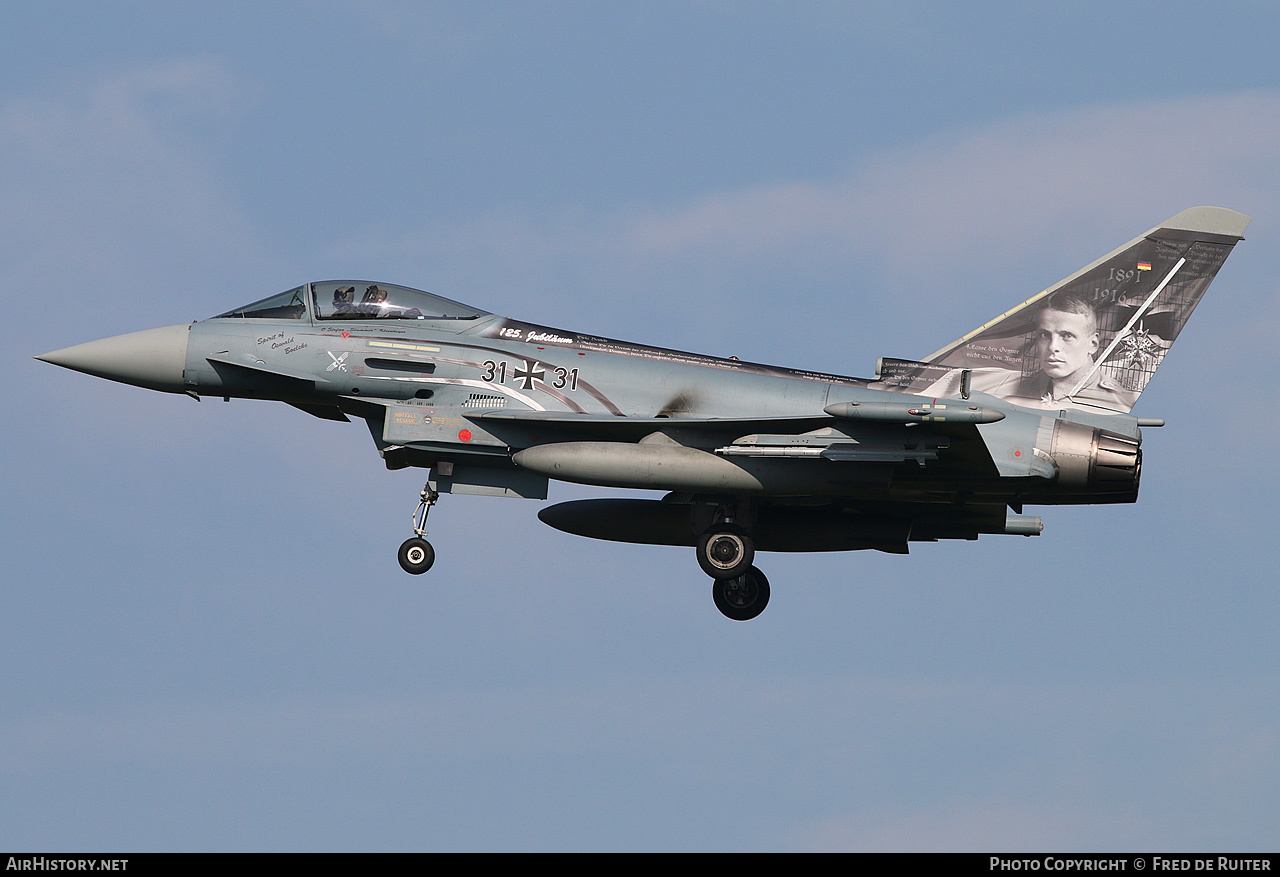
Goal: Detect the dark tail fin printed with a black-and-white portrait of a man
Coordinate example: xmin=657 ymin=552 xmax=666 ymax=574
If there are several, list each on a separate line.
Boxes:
xmin=878 ymin=207 xmax=1249 ymax=414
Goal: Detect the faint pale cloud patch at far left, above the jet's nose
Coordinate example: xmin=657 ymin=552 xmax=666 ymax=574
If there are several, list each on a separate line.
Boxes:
xmin=0 ymin=56 xmax=256 ymax=327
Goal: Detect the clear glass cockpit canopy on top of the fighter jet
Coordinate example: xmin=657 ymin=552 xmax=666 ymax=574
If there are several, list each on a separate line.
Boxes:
xmin=214 ymin=280 xmax=488 ymax=320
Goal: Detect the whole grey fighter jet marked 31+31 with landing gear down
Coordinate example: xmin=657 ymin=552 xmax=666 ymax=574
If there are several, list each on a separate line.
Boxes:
xmin=36 ymin=207 xmax=1249 ymax=621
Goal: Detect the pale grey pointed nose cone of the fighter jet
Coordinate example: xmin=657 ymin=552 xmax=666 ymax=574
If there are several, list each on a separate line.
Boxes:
xmin=36 ymin=325 xmax=191 ymax=393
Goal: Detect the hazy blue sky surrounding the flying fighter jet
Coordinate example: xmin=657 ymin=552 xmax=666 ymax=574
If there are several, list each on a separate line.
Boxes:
xmin=0 ymin=3 xmax=1280 ymax=851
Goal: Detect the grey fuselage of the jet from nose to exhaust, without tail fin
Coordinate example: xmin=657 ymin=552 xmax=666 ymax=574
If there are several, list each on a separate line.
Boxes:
xmin=50 ymin=276 xmax=1139 ymax=506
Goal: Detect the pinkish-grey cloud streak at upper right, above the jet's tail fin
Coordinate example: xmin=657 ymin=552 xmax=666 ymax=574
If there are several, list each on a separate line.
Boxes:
xmin=609 ymin=92 xmax=1280 ymax=271
